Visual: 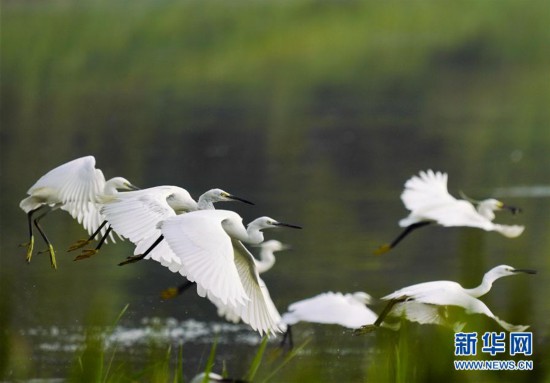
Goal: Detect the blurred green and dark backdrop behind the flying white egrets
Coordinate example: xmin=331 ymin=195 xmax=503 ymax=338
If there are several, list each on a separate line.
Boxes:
xmin=0 ymin=0 xmax=550 ymax=382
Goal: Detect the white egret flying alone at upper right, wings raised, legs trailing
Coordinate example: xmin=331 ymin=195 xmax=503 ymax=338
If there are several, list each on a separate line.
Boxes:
xmin=375 ymin=170 xmax=524 ymax=254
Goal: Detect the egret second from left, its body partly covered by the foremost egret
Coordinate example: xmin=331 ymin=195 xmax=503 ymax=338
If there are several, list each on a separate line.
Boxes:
xmin=72 ymin=186 xmax=253 ymax=262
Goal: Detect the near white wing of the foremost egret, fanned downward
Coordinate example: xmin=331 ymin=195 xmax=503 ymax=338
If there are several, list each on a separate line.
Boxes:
xmin=159 ymin=210 xmax=248 ymax=307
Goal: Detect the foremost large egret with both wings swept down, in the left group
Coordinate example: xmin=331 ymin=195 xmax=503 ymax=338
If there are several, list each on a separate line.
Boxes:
xmin=135 ymin=210 xmax=301 ymax=334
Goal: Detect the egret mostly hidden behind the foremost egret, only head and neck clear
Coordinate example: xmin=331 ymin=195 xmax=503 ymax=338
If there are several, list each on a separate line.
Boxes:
xmin=160 ymin=239 xmax=289 ymax=300
